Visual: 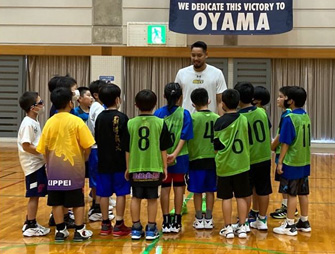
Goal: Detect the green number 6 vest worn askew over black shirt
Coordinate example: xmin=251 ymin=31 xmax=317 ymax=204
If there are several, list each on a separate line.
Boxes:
xmin=214 ymin=113 xmax=250 ymax=177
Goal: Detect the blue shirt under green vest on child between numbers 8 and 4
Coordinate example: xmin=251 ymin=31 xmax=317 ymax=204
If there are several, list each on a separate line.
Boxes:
xmin=154 ymin=106 xmax=193 ymax=174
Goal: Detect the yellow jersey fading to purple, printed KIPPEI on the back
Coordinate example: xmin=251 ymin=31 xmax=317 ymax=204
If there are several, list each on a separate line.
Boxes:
xmin=36 ymin=112 xmax=95 ymax=190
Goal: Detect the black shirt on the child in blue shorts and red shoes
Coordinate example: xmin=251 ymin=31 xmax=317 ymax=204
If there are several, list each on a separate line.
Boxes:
xmin=95 ymin=109 xmax=129 ymax=173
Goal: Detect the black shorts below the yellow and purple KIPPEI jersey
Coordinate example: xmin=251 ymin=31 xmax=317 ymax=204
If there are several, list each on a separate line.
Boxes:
xmin=48 ymin=189 xmax=85 ymax=208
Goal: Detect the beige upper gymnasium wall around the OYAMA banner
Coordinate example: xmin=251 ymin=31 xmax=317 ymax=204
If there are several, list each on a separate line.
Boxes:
xmin=0 ymin=0 xmax=335 ymax=47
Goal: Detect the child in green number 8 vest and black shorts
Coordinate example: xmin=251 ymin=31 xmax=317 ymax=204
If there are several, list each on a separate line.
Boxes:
xmin=125 ymin=89 xmax=172 ymax=240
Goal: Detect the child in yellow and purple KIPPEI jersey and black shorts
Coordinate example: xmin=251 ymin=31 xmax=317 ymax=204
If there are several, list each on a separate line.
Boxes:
xmin=36 ymin=87 xmax=94 ymax=241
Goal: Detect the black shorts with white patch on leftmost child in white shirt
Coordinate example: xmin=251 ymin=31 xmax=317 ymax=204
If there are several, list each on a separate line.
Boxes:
xmin=25 ymin=165 xmax=48 ymax=198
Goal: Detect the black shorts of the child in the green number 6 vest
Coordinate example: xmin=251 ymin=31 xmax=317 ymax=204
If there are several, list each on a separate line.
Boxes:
xmin=217 ymin=171 xmax=252 ymax=199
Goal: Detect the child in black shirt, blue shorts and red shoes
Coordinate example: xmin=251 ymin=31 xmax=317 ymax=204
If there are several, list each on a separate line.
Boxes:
xmin=95 ymin=84 xmax=130 ymax=236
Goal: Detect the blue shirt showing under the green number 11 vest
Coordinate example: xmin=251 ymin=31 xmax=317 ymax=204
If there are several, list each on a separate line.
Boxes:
xmin=279 ymin=108 xmax=311 ymax=180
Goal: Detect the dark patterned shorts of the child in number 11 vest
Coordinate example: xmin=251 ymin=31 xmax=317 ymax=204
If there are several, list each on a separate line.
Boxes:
xmin=279 ymin=176 xmax=309 ymax=196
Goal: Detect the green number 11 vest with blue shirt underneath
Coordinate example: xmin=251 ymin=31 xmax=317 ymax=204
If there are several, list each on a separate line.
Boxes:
xmin=279 ymin=108 xmax=311 ymax=179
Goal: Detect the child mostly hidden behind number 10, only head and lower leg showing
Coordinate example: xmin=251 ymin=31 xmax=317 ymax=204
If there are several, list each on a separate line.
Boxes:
xmin=248 ymin=86 xmax=270 ymax=223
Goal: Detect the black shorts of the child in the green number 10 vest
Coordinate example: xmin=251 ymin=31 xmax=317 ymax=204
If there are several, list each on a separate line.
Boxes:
xmin=250 ymin=160 xmax=272 ymax=196
